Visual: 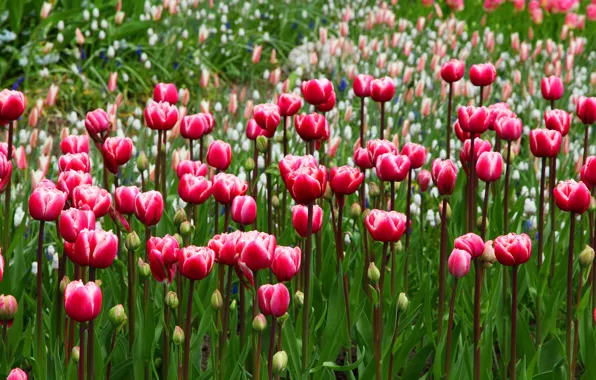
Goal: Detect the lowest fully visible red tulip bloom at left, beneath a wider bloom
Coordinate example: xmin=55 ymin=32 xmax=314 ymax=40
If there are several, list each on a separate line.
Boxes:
xmin=64 ymin=280 xmax=102 ymax=322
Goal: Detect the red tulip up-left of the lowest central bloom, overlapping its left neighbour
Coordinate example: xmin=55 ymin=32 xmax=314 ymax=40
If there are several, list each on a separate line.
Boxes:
xmin=236 ymin=230 xmax=276 ymax=272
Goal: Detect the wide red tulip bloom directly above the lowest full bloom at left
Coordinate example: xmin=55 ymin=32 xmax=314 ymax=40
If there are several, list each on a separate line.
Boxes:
xmin=74 ymin=229 xmax=118 ymax=269
